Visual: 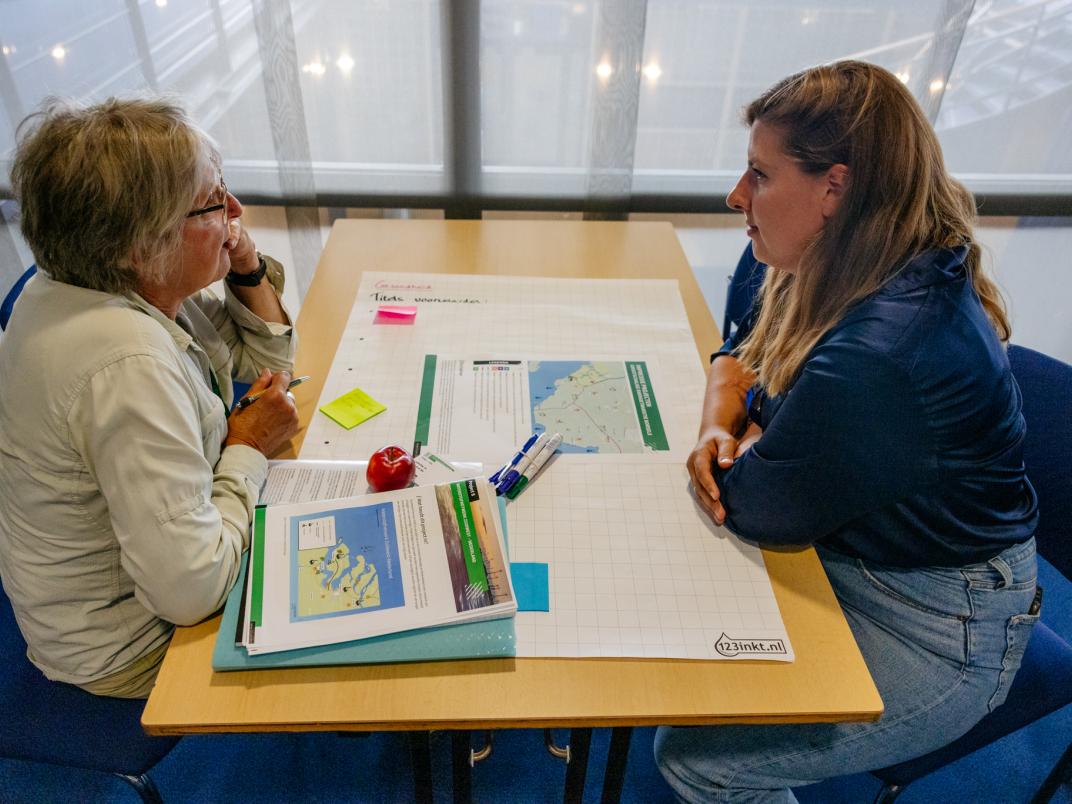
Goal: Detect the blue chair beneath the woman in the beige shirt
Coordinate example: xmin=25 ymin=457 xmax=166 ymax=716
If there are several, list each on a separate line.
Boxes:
xmin=0 ymin=578 xmax=179 ymax=803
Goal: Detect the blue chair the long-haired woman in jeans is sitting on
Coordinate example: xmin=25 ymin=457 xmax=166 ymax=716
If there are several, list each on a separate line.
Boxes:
xmin=872 ymin=346 xmax=1072 ymax=804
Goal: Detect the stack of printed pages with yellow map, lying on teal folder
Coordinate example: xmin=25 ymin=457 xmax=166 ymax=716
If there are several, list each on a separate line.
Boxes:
xmin=242 ymin=479 xmax=517 ymax=656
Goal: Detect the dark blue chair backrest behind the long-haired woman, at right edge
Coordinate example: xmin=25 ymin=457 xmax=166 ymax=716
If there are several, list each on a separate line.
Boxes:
xmin=1009 ymin=345 xmax=1072 ymax=580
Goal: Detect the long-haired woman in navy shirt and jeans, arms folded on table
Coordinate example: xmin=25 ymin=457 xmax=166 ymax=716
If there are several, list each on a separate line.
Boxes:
xmin=656 ymin=61 xmax=1038 ymax=802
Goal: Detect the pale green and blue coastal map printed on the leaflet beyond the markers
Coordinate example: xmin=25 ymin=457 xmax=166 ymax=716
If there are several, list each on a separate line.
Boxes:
xmin=528 ymin=360 xmax=645 ymax=453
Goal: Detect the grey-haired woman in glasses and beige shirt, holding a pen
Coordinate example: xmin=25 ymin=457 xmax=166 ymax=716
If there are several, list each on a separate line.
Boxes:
xmin=0 ymin=100 xmax=297 ymax=697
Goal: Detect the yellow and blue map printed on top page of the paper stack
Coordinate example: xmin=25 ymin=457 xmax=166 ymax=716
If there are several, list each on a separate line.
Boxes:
xmin=291 ymin=503 xmax=405 ymax=622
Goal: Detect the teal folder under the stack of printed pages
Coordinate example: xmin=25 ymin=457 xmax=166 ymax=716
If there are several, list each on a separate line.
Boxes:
xmin=212 ymin=500 xmax=517 ymax=671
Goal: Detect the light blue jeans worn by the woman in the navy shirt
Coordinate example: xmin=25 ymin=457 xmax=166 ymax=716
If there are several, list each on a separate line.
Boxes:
xmin=655 ymin=539 xmax=1039 ymax=804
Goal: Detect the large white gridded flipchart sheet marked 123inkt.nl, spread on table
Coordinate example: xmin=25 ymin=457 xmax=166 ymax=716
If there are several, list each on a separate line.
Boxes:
xmin=300 ymin=272 xmax=793 ymax=661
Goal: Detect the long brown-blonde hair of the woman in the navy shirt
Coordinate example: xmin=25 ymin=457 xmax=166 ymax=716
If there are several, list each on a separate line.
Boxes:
xmin=738 ymin=60 xmax=1011 ymax=394
